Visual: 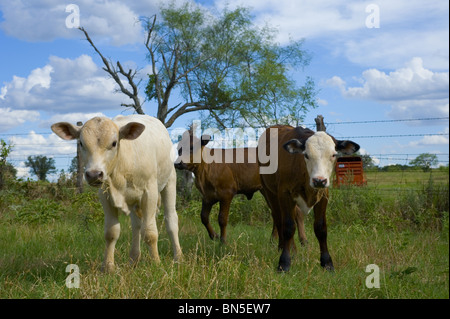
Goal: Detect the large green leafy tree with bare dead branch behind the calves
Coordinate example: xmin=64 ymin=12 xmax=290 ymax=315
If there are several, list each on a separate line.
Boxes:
xmin=80 ymin=2 xmax=317 ymax=128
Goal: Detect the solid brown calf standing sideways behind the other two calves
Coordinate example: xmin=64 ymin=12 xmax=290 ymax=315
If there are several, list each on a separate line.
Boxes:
xmin=175 ymin=131 xmax=306 ymax=244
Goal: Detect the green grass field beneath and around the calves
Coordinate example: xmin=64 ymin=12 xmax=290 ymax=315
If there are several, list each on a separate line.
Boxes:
xmin=0 ymin=172 xmax=449 ymax=299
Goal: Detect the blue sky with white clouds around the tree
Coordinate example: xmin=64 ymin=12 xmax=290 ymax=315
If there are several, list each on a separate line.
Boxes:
xmin=0 ymin=0 xmax=449 ymax=177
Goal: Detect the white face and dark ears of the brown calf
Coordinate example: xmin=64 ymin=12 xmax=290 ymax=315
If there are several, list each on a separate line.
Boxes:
xmin=283 ymin=132 xmax=359 ymax=188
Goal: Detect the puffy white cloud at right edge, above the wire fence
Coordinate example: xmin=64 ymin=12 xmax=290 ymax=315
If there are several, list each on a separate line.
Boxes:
xmin=326 ymin=58 xmax=449 ymax=118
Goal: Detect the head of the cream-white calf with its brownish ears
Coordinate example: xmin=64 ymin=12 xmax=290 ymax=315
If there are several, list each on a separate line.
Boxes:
xmin=52 ymin=117 xmax=145 ymax=186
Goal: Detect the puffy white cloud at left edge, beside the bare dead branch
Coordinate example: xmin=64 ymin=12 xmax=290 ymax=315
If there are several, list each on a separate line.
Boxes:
xmin=0 ymin=55 xmax=137 ymax=113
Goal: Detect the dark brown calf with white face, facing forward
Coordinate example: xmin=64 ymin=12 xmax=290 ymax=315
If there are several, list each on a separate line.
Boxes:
xmin=258 ymin=125 xmax=359 ymax=271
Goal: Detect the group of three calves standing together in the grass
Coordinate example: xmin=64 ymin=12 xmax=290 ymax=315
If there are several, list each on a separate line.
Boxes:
xmin=51 ymin=115 xmax=359 ymax=272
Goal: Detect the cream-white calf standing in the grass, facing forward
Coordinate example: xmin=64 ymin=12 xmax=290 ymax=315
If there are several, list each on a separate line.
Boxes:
xmin=52 ymin=115 xmax=182 ymax=271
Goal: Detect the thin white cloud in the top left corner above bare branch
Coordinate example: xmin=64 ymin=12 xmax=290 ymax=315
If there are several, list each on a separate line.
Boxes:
xmin=0 ymin=0 xmax=156 ymax=46
